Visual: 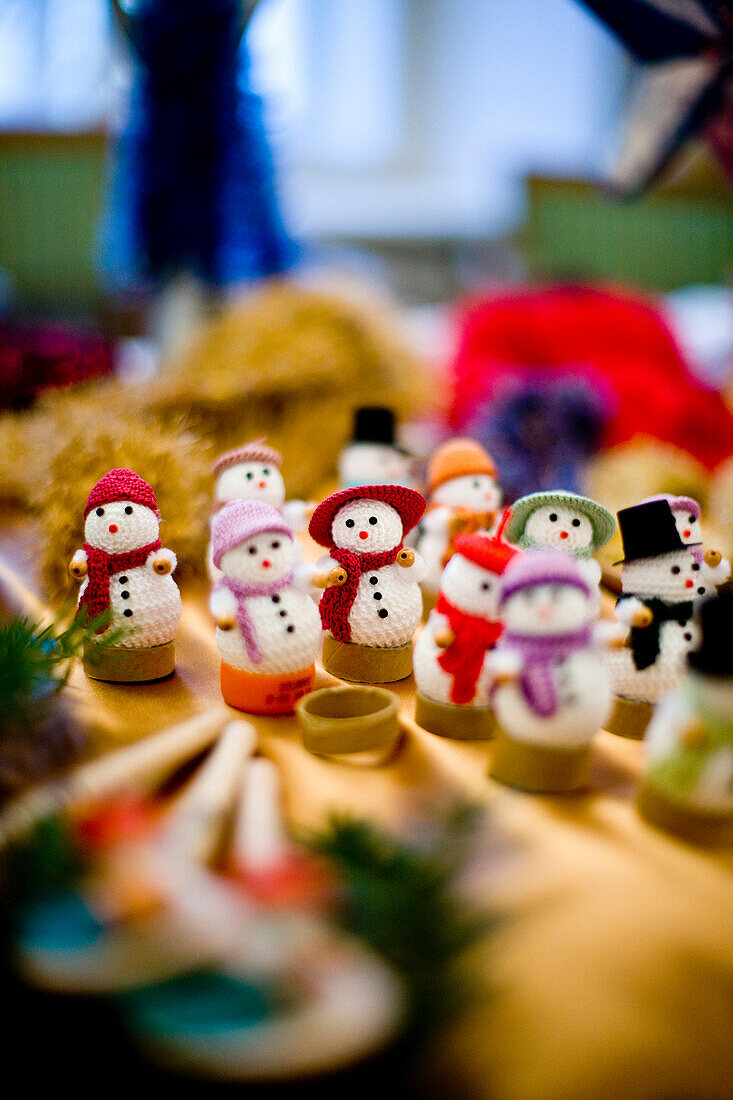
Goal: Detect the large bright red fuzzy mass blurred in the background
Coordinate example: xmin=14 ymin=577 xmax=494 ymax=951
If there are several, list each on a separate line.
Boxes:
xmin=449 ymin=286 xmax=733 ymax=469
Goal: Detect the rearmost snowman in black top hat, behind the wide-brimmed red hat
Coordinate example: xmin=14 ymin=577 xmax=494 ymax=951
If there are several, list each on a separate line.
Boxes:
xmin=339 ymin=406 xmax=413 ymax=488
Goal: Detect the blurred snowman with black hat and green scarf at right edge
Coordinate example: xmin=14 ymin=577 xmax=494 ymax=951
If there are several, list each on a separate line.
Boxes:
xmin=638 ymin=593 xmax=733 ymax=844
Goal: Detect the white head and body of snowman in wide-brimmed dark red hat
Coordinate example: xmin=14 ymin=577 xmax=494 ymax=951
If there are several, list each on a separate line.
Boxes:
xmin=318 ymin=499 xmax=425 ymax=648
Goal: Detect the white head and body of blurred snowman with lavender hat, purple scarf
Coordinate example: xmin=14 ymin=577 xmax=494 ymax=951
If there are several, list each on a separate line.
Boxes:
xmin=492 ymin=584 xmax=611 ymax=749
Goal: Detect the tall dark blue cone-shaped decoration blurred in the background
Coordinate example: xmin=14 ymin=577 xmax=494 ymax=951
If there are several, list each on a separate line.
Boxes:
xmin=102 ymin=0 xmax=296 ymax=287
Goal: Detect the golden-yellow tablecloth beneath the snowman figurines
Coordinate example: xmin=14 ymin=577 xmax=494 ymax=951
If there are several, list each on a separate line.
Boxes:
xmin=0 ymin=521 xmax=733 ymax=1100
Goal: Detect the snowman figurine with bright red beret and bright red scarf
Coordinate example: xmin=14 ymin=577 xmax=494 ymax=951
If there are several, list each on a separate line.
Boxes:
xmin=413 ymin=525 xmax=519 ymax=739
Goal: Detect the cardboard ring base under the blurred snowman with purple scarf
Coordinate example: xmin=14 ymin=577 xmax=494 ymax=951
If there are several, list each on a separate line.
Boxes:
xmin=490 ymin=724 xmax=591 ymax=794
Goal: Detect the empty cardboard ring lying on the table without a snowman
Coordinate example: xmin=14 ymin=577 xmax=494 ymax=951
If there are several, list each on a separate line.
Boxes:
xmin=296 ymin=688 xmax=402 ymax=756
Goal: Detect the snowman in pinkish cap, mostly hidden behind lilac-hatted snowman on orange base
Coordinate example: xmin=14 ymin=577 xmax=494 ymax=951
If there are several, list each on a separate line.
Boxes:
xmin=207 ymin=439 xmax=315 ymax=581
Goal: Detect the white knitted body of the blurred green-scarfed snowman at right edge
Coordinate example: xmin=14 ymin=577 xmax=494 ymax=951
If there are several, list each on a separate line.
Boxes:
xmin=645 ymin=675 xmax=733 ymax=815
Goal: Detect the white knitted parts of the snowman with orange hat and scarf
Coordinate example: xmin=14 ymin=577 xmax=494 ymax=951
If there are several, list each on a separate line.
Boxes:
xmin=417 ymin=474 xmax=502 ymax=592
